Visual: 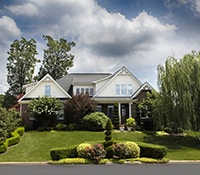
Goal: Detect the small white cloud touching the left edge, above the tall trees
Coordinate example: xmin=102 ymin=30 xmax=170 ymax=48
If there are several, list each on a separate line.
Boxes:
xmin=0 ymin=16 xmax=21 ymax=44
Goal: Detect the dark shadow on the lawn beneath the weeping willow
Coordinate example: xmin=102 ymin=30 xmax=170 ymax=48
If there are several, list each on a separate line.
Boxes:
xmin=144 ymin=133 xmax=200 ymax=149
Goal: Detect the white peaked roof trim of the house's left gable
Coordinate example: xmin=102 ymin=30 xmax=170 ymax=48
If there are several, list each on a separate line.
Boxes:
xmin=18 ymin=74 xmax=71 ymax=102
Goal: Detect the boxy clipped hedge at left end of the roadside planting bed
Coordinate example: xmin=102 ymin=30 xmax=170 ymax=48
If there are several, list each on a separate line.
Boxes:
xmin=50 ymin=146 xmax=77 ymax=160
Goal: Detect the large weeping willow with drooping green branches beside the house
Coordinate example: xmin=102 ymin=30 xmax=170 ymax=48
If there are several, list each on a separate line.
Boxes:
xmin=158 ymin=51 xmax=200 ymax=131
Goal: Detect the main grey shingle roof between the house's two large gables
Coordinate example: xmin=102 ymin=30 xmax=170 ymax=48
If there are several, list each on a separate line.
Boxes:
xmin=57 ymin=73 xmax=112 ymax=91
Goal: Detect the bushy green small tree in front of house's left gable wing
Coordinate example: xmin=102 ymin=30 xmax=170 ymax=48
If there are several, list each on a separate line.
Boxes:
xmin=28 ymin=97 xmax=63 ymax=128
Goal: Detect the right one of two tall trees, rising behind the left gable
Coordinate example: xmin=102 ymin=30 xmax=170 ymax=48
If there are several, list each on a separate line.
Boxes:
xmin=35 ymin=35 xmax=75 ymax=80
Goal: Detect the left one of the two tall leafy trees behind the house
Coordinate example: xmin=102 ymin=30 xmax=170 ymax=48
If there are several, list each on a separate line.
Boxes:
xmin=7 ymin=37 xmax=40 ymax=96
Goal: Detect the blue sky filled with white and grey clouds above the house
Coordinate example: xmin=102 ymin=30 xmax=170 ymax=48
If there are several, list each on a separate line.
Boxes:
xmin=0 ymin=0 xmax=200 ymax=93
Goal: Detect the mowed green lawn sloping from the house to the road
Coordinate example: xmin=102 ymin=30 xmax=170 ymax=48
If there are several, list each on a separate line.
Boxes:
xmin=0 ymin=131 xmax=200 ymax=162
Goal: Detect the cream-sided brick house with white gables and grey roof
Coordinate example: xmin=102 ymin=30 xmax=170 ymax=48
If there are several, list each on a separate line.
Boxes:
xmin=19 ymin=67 xmax=153 ymax=129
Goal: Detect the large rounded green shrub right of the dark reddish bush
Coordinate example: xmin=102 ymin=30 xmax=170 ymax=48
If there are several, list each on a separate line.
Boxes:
xmin=82 ymin=112 xmax=109 ymax=131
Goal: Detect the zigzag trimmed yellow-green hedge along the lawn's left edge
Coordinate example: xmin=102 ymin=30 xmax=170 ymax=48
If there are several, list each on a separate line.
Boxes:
xmin=0 ymin=127 xmax=24 ymax=153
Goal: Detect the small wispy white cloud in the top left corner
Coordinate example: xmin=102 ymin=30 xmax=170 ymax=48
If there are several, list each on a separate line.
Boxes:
xmin=6 ymin=3 xmax=39 ymax=16
